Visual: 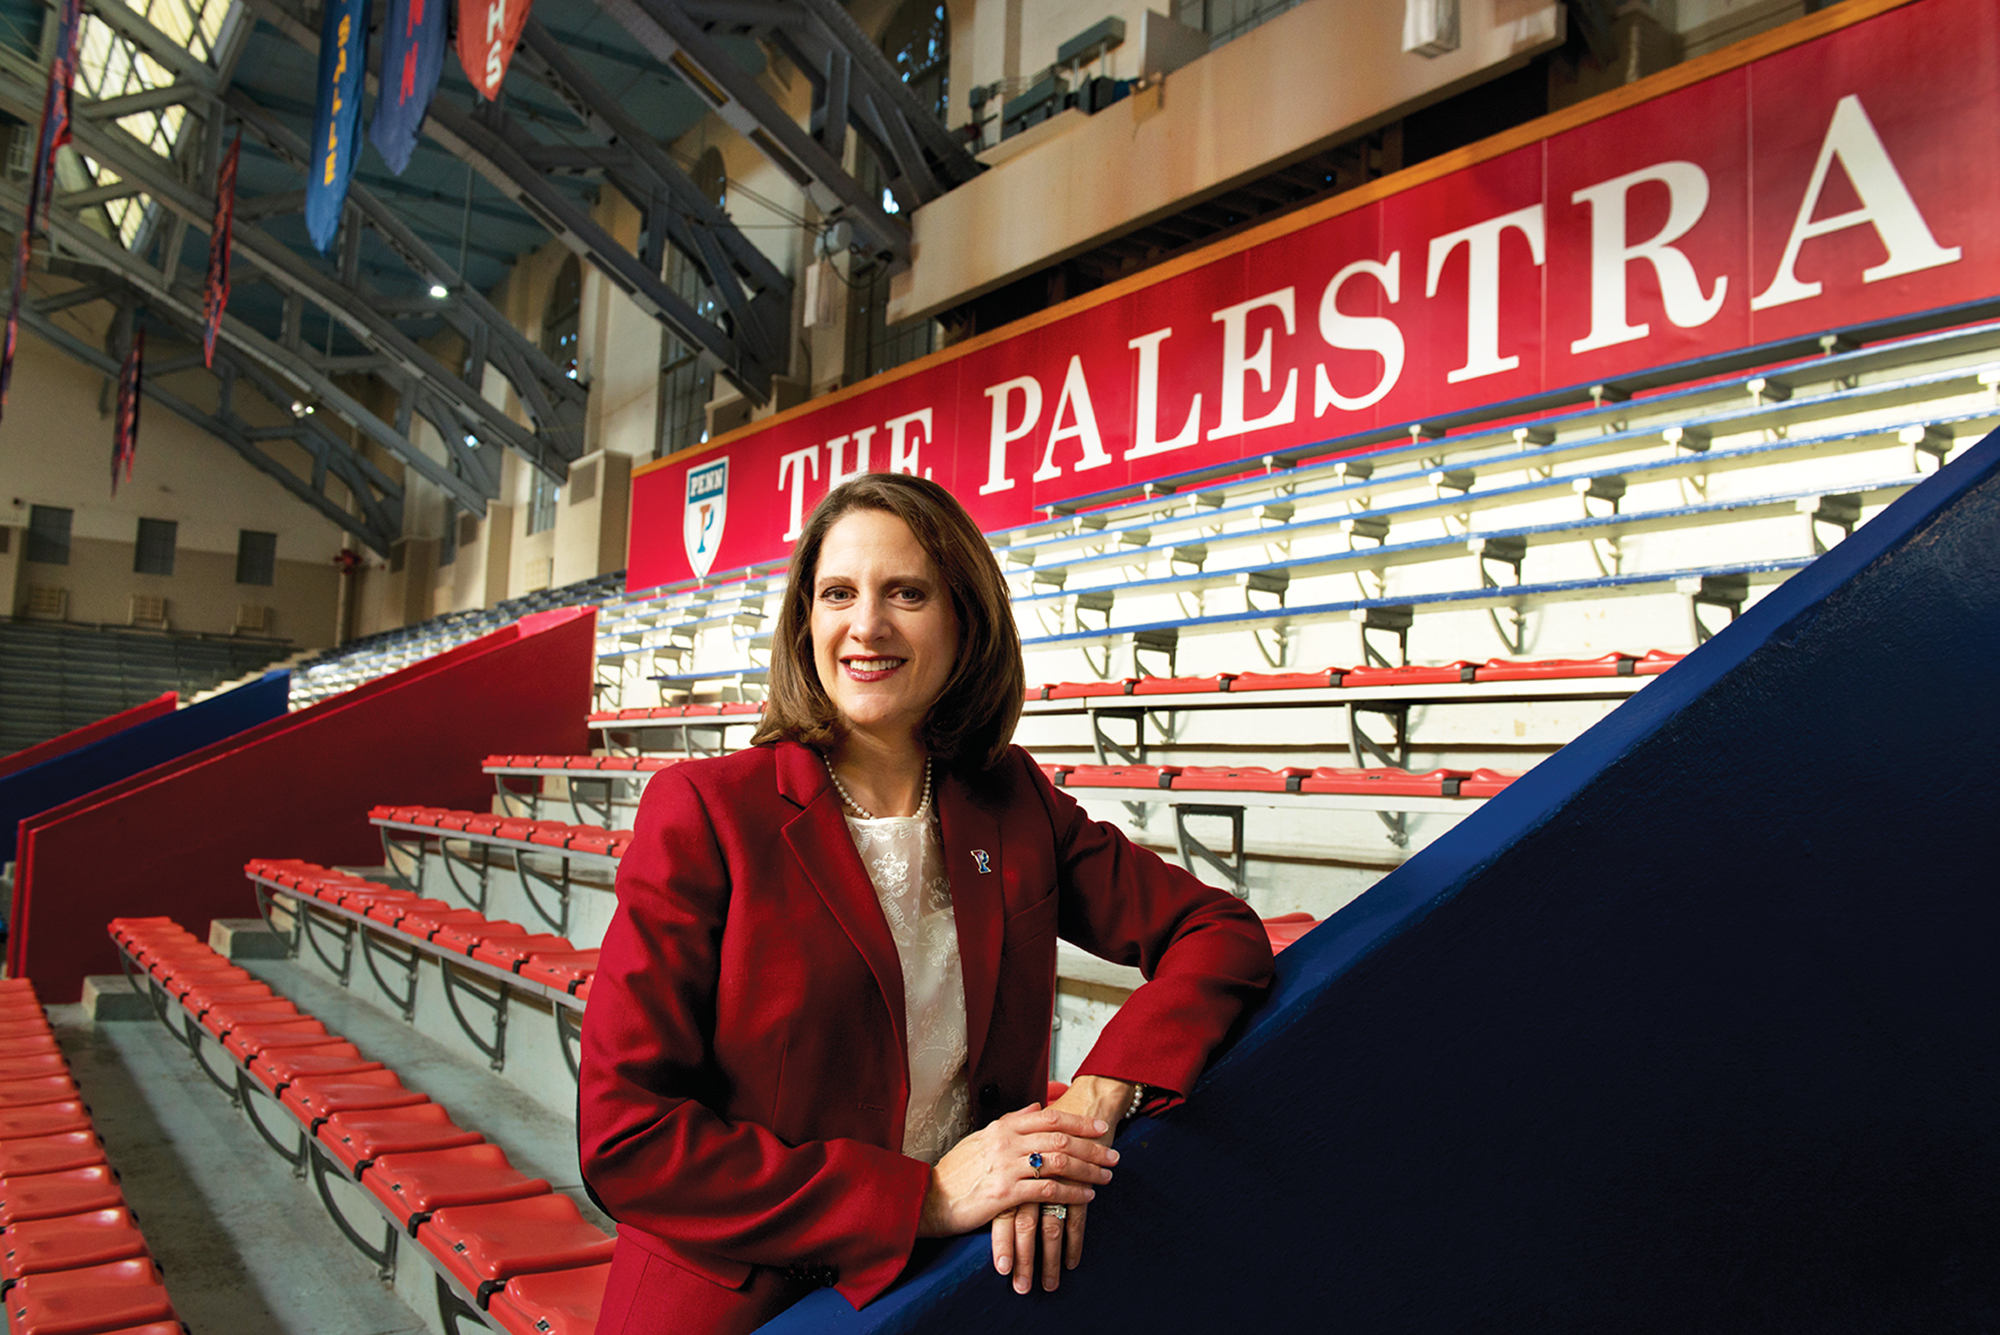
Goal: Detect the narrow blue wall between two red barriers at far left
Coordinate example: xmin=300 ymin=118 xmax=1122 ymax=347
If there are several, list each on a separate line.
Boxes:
xmin=0 ymin=671 xmax=292 ymax=875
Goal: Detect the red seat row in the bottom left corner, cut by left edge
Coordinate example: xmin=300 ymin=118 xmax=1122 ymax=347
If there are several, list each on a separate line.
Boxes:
xmin=0 ymin=979 xmax=182 ymax=1335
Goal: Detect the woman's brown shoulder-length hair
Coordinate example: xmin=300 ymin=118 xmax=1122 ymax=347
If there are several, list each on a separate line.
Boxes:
xmin=750 ymin=474 xmax=1026 ymax=775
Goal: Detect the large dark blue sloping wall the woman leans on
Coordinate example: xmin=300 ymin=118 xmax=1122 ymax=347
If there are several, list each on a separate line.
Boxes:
xmin=766 ymin=434 xmax=2000 ymax=1335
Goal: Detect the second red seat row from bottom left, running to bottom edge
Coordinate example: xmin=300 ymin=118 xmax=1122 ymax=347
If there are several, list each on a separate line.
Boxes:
xmin=110 ymin=917 xmax=612 ymax=1335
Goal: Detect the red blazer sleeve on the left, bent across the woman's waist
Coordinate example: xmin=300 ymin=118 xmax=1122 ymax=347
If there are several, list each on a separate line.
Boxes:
xmin=578 ymin=769 xmax=930 ymax=1307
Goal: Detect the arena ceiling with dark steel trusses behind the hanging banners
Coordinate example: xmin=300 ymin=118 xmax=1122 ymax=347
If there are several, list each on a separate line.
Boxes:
xmin=0 ymin=0 xmax=978 ymax=552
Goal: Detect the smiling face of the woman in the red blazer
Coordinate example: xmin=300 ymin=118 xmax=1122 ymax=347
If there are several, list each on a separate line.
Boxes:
xmin=812 ymin=510 xmax=958 ymax=743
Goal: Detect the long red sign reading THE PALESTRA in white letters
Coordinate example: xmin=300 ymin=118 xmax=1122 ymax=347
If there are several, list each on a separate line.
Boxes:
xmin=628 ymin=0 xmax=2000 ymax=590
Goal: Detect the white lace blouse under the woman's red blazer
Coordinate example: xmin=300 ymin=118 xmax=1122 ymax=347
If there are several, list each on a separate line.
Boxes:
xmin=846 ymin=811 xmax=972 ymax=1163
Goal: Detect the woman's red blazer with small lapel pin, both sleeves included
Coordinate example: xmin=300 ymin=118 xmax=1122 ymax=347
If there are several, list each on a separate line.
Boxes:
xmin=578 ymin=741 xmax=1272 ymax=1331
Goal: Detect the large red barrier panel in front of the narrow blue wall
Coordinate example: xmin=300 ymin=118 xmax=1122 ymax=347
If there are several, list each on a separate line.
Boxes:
xmin=8 ymin=608 xmax=596 ymax=1001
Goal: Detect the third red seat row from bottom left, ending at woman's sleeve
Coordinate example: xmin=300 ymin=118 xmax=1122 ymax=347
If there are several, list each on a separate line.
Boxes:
xmin=244 ymin=857 xmax=598 ymax=997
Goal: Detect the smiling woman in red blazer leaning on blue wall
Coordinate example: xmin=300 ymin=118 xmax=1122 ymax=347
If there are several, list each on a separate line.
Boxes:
xmin=578 ymin=474 xmax=1272 ymax=1333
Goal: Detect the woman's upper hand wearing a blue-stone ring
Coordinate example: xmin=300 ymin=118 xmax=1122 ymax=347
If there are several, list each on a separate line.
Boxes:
xmin=916 ymin=1103 xmax=1116 ymax=1237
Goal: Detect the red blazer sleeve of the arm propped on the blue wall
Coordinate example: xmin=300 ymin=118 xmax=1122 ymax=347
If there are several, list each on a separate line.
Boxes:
xmin=1022 ymin=755 xmax=1274 ymax=1109
